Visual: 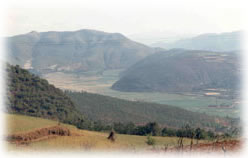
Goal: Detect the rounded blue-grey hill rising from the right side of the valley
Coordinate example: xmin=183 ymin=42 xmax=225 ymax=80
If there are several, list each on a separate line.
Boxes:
xmin=112 ymin=49 xmax=240 ymax=92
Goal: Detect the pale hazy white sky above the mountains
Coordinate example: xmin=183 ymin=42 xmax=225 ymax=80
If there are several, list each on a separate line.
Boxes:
xmin=1 ymin=0 xmax=244 ymax=36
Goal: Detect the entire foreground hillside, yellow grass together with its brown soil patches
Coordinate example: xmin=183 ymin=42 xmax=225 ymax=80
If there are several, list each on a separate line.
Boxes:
xmin=4 ymin=114 xmax=241 ymax=153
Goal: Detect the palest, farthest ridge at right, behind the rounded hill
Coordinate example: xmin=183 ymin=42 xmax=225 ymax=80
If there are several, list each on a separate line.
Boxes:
xmin=151 ymin=31 xmax=242 ymax=52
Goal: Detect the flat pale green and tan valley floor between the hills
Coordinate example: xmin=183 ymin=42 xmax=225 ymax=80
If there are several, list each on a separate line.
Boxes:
xmin=42 ymin=70 xmax=240 ymax=117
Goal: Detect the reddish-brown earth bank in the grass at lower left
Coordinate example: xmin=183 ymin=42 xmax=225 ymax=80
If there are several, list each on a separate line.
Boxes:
xmin=7 ymin=126 xmax=80 ymax=144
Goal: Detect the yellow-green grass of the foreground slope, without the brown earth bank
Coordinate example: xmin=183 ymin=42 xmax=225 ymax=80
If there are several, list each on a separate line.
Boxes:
xmin=5 ymin=114 xmax=206 ymax=151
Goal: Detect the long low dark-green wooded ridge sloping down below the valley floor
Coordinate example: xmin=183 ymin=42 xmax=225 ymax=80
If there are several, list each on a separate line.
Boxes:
xmin=66 ymin=91 xmax=222 ymax=128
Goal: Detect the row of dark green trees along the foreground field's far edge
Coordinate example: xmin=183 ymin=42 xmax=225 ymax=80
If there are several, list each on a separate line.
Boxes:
xmin=79 ymin=121 xmax=227 ymax=140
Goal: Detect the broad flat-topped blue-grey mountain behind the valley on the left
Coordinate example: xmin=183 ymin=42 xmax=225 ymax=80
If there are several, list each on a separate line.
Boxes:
xmin=7 ymin=30 xmax=154 ymax=73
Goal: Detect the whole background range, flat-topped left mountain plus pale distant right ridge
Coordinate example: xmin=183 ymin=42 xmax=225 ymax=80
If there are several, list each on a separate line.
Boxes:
xmin=6 ymin=29 xmax=241 ymax=74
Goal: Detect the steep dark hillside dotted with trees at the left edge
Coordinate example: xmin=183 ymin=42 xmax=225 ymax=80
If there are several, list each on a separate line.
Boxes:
xmin=6 ymin=65 xmax=87 ymax=127
